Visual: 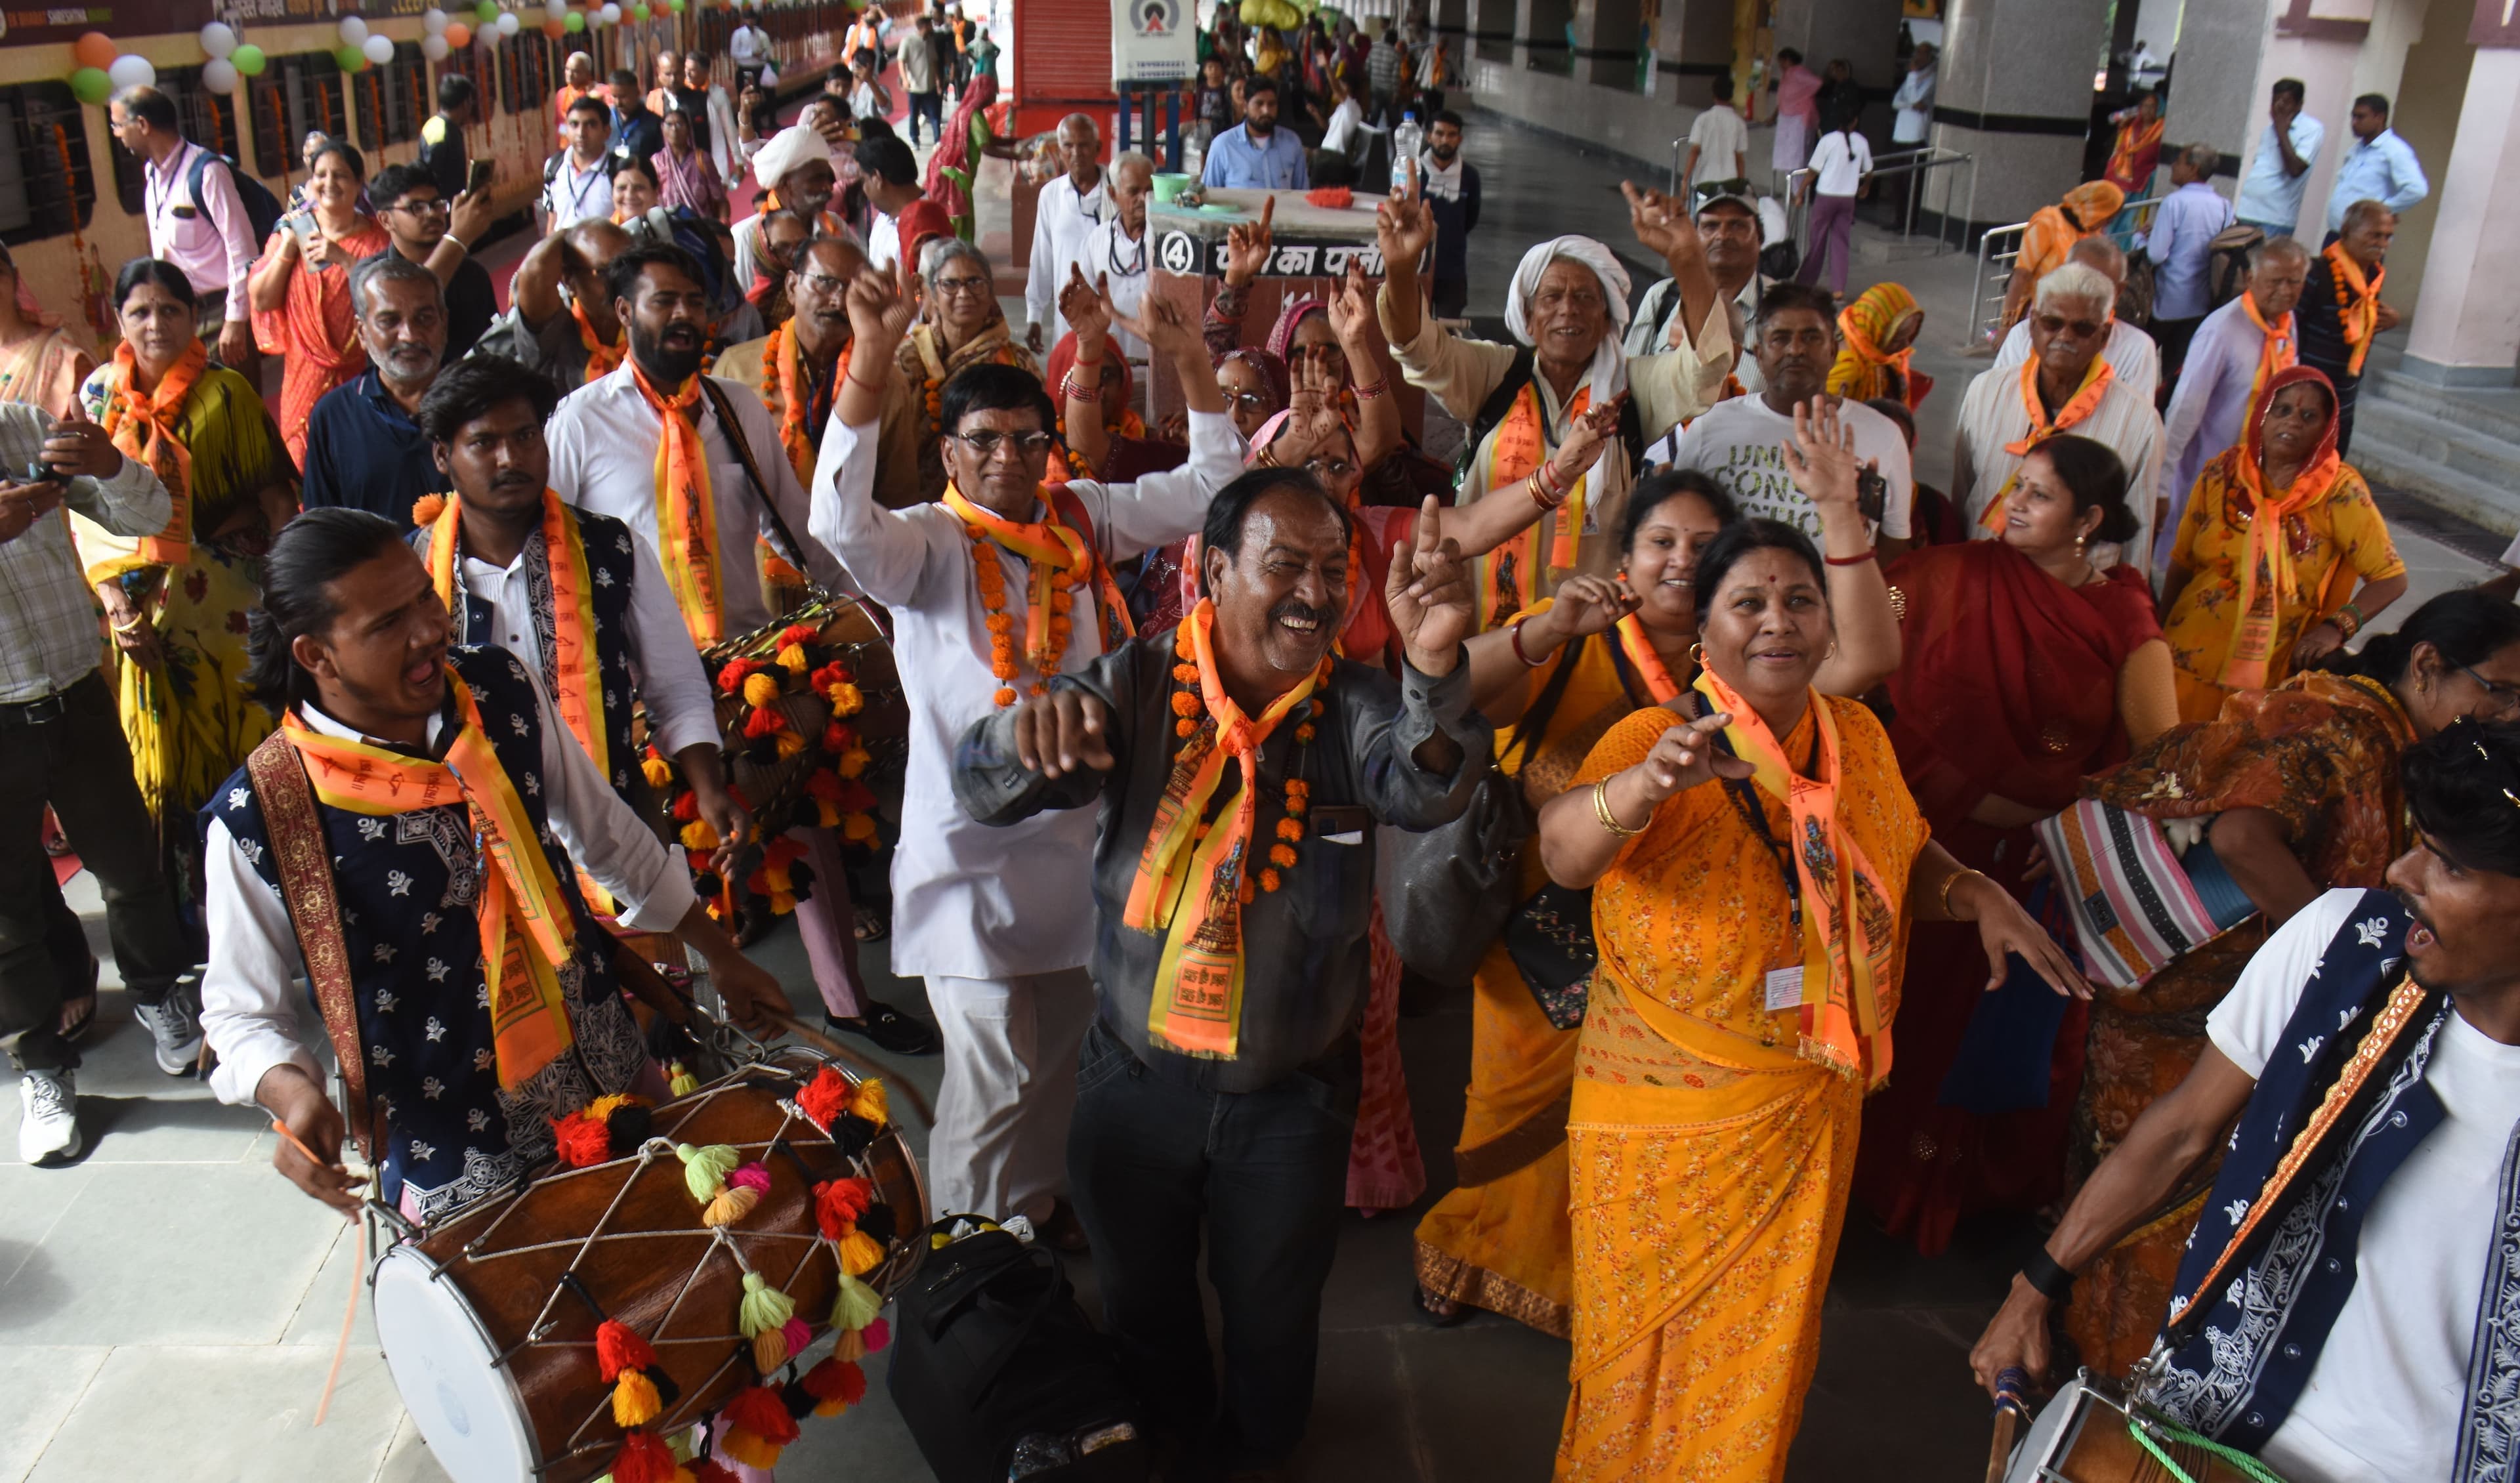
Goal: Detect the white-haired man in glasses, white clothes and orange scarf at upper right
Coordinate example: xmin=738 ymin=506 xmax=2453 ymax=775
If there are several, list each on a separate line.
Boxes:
xmin=1950 ymin=262 xmax=2162 ymax=572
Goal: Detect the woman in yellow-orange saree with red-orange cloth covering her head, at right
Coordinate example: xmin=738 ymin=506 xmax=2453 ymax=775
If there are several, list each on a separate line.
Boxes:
xmin=2162 ymin=365 xmax=2406 ymax=720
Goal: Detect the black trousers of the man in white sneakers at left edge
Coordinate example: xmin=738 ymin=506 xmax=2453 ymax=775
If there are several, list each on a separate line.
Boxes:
xmin=0 ymin=675 xmax=194 ymax=1070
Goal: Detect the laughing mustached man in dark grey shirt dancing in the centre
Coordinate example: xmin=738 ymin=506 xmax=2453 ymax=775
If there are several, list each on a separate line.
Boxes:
xmin=955 ymin=469 xmax=1492 ymax=1478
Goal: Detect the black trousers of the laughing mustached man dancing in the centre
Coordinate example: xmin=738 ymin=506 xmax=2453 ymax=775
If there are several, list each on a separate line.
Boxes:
xmin=1068 ymin=1022 xmax=1363 ymax=1465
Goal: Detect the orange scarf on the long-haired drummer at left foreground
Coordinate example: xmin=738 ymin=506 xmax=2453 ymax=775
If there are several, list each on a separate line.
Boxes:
xmin=280 ymin=670 xmax=577 ymax=1090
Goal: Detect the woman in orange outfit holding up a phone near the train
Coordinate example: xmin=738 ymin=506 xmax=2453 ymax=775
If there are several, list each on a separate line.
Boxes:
xmin=247 ymin=138 xmax=393 ymax=466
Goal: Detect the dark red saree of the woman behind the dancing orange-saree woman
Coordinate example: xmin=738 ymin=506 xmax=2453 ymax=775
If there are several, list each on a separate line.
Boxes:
xmin=1855 ymin=541 xmax=2162 ymax=1257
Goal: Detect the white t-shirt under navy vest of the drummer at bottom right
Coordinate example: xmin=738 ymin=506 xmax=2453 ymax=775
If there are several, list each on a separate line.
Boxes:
xmin=2205 ymin=891 xmax=2520 ymax=1483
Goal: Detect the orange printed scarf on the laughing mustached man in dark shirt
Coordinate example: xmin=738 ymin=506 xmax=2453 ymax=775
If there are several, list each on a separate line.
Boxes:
xmin=1122 ymin=599 xmax=1331 ymax=1060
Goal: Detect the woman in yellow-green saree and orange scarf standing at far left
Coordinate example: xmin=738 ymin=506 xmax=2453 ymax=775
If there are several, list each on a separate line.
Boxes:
xmin=71 ymin=257 xmax=297 ymax=896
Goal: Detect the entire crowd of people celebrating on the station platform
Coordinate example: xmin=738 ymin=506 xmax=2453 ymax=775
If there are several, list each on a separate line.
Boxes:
xmin=0 ymin=8 xmax=2520 ymax=1483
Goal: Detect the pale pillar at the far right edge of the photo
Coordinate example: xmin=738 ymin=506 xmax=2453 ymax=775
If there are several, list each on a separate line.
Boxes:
xmin=2404 ymin=48 xmax=2520 ymax=385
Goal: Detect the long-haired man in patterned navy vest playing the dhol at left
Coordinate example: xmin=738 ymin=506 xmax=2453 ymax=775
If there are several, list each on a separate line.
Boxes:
xmin=201 ymin=509 xmax=786 ymax=1224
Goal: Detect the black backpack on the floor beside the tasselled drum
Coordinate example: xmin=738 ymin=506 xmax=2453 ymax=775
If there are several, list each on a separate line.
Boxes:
xmin=890 ymin=1216 xmax=1152 ymax=1483
